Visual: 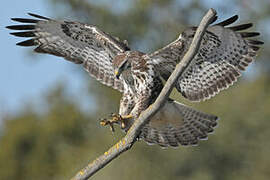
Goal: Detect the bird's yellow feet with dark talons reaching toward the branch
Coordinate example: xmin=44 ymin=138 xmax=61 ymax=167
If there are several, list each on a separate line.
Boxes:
xmin=100 ymin=113 xmax=133 ymax=132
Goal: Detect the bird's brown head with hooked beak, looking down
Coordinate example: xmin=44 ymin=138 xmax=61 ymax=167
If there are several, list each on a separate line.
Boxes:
xmin=113 ymin=51 xmax=131 ymax=79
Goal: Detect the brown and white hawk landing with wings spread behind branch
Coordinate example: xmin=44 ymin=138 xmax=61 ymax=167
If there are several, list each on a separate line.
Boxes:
xmin=7 ymin=13 xmax=263 ymax=147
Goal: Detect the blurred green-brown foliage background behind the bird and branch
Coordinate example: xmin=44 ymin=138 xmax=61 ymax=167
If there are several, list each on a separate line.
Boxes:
xmin=0 ymin=0 xmax=270 ymax=180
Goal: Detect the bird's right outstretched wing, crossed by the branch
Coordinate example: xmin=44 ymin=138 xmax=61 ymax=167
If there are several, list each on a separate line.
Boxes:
xmin=149 ymin=16 xmax=263 ymax=101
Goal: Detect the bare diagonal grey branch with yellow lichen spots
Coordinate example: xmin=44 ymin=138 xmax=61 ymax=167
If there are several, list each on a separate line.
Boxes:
xmin=72 ymin=9 xmax=216 ymax=180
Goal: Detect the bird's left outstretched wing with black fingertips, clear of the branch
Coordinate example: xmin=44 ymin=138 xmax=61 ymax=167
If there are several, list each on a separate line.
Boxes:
xmin=7 ymin=13 xmax=129 ymax=91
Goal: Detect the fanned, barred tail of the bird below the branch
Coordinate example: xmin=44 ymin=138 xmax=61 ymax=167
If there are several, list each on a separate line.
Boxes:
xmin=140 ymin=100 xmax=218 ymax=147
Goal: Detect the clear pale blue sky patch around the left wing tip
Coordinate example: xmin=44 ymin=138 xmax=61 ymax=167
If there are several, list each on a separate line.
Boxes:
xmin=0 ymin=0 xmax=89 ymax=121
